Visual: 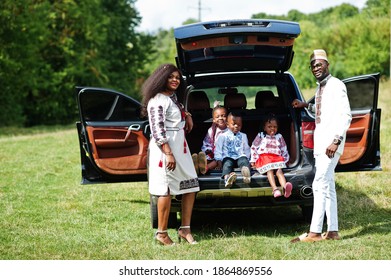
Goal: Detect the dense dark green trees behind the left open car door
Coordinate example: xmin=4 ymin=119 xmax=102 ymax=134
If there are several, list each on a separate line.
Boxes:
xmin=0 ymin=0 xmax=153 ymax=125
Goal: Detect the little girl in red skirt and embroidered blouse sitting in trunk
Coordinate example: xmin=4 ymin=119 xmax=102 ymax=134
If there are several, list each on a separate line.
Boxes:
xmin=250 ymin=114 xmax=292 ymax=198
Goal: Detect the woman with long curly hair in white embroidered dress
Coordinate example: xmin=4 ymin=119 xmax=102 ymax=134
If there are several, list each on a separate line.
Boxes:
xmin=141 ymin=64 xmax=199 ymax=245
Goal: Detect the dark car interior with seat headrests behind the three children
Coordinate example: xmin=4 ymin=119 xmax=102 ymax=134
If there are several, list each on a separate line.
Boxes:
xmin=187 ymin=85 xmax=298 ymax=170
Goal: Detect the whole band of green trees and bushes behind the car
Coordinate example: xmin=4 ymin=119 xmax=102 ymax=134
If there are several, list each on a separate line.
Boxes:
xmin=0 ymin=0 xmax=390 ymax=126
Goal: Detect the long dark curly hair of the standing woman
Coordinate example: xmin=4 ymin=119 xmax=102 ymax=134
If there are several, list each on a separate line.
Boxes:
xmin=141 ymin=63 xmax=186 ymax=117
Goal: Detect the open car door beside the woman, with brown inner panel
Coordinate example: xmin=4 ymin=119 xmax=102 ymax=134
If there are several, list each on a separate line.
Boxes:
xmin=76 ymin=87 xmax=149 ymax=184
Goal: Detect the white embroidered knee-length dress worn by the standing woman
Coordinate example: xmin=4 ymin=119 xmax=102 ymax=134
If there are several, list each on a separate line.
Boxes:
xmin=147 ymin=93 xmax=199 ymax=195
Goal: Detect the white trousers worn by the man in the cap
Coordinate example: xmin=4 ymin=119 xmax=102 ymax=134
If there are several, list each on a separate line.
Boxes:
xmin=310 ymin=153 xmax=341 ymax=233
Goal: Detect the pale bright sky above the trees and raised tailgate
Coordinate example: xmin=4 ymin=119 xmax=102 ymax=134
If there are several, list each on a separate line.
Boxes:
xmin=135 ymin=0 xmax=366 ymax=32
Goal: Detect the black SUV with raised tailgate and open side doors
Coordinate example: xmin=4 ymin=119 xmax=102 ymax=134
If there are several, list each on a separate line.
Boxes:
xmin=77 ymin=19 xmax=381 ymax=227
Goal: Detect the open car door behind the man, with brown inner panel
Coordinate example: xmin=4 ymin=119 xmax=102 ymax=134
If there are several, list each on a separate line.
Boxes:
xmin=336 ymin=73 xmax=381 ymax=171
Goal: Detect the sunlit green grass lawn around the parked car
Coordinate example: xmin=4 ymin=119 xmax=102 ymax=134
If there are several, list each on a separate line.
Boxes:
xmin=0 ymin=81 xmax=391 ymax=260
